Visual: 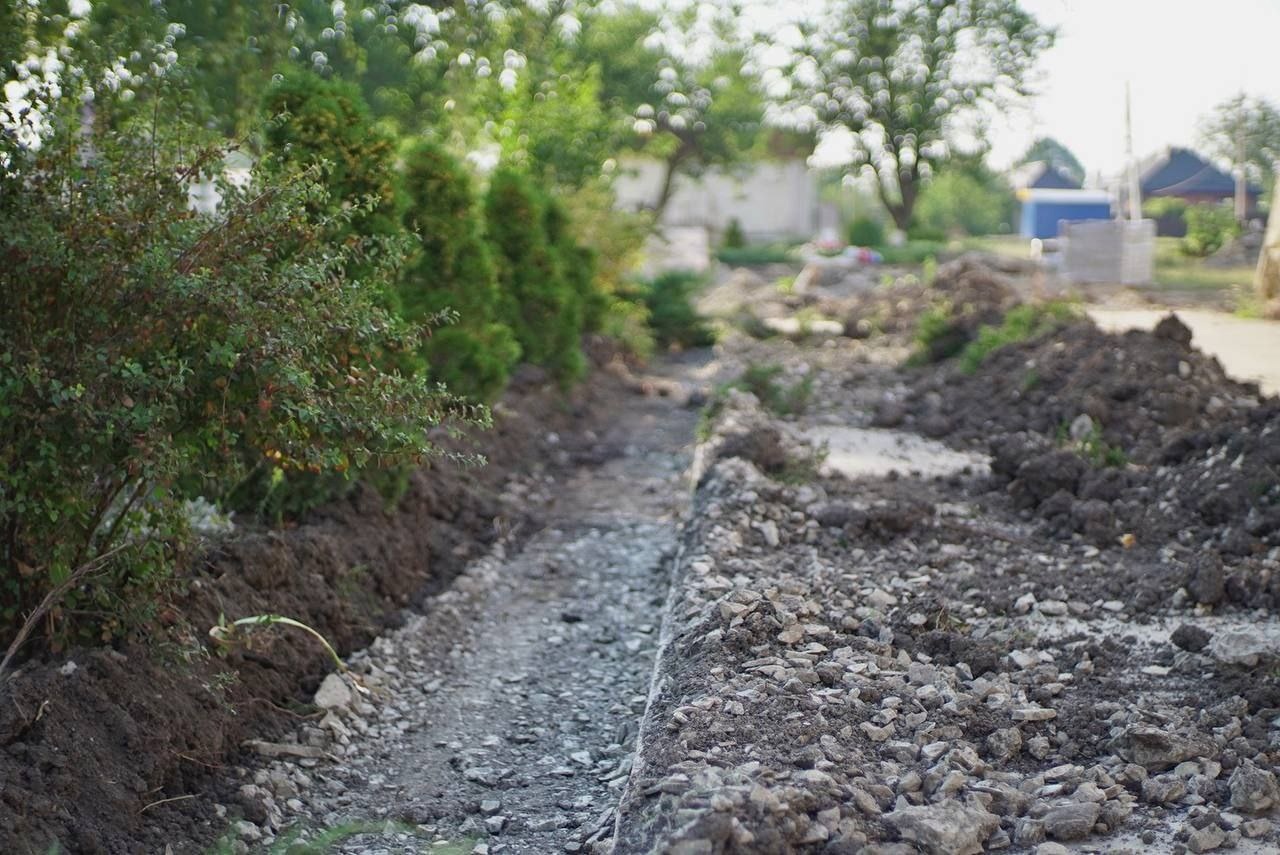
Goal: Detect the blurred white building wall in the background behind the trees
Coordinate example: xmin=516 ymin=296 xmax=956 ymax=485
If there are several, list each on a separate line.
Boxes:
xmin=614 ymin=160 xmax=819 ymax=241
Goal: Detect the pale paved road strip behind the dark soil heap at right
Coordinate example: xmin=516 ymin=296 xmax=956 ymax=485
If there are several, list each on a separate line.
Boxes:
xmin=1089 ymin=308 xmax=1280 ymax=394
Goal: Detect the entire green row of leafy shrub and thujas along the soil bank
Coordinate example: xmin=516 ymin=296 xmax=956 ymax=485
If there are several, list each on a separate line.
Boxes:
xmin=0 ymin=74 xmax=607 ymax=668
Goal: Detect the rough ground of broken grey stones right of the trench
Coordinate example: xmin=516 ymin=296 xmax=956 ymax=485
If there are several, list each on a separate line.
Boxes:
xmin=606 ymin=396 xmax=1280 ymax=855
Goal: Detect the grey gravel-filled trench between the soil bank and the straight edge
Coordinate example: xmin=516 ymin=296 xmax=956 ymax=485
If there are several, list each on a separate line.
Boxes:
xmin=213 ymin=362 xmax=698 ymax=854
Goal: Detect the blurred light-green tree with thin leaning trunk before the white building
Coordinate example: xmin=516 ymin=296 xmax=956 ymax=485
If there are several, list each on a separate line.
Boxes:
xmin=582 ymin=6 xmax=764 ymax=216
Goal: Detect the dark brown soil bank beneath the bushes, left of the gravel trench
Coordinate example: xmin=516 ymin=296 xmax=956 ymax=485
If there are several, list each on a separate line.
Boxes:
xmin=0 ymin=347 xmax=655 ymax=855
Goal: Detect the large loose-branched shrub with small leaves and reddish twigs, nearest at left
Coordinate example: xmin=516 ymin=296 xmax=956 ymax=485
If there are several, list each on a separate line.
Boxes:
xmin=0 ymin=115 xmax=484 ymax=641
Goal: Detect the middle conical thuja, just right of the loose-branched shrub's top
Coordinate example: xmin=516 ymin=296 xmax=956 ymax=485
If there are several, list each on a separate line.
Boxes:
xmin=399 ymin=142 xmax=520 ymax=401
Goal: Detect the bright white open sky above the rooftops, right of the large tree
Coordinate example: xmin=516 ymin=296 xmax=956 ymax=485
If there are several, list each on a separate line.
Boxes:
xmin=991 ymin=0 xmax=1280 ymax=177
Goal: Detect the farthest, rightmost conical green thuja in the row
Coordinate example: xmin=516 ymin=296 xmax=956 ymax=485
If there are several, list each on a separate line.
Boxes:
xmin=485 ymin=166 xmax=586 ymax=385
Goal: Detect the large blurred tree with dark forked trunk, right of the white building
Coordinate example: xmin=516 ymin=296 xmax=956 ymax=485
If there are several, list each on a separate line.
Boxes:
xmin=790 ymin=0 xmax=1053 ymax=229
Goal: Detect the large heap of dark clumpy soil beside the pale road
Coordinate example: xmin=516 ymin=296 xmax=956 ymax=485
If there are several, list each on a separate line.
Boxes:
xmin=896 ymin=316 xmax=1280 ymax=608
